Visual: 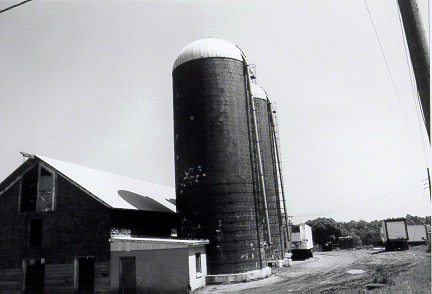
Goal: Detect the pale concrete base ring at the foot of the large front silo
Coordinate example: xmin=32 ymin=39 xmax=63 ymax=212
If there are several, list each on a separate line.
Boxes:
xmin=206 ymin=267 xmax=271 ymax=285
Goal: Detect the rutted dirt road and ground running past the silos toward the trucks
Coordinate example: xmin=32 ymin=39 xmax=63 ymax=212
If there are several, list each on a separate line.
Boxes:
xmin=194 ymin=246 xmax=431 ymax=294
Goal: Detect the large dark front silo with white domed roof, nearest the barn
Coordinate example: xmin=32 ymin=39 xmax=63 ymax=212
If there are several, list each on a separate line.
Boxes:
xmin=173 ymin=39 xmax=263 ymax=274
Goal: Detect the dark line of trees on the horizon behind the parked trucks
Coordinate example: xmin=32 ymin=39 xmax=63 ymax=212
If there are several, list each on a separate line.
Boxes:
xmin=306 ymin=214 xmax=431 ymax=247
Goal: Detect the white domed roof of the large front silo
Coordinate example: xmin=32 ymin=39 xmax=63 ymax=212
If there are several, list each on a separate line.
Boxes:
xmin=173 ymin=38 xmax=243 ymax=70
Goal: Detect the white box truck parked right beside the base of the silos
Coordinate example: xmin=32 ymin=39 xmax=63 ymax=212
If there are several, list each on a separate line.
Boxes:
xmin=291 ymin=224 xmax=313 ymax=259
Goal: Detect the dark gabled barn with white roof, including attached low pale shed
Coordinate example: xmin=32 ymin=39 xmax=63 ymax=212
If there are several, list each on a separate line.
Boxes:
xmin=0 ymin=153 xmax=208 ymax=293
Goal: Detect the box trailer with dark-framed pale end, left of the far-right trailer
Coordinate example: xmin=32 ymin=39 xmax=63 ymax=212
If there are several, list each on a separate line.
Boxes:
xmin=380 ymin=218 xmax=409 ymax=251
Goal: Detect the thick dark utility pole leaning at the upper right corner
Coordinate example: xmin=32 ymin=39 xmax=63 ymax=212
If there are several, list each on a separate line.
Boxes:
xmin=398 ymin=0 xmax=431 ymax=142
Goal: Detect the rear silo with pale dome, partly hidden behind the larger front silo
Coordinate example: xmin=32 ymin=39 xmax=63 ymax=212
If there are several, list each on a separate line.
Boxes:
xmin=251 ymin=84 xmax=284 ymax=259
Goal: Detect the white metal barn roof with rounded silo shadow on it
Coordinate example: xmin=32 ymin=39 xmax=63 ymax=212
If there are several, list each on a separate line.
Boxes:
xmin=34 ymin=155 xmax=176 ymax=212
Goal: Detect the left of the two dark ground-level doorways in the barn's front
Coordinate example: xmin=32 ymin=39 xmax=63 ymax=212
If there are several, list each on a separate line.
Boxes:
xmin=24 ymin=259 xmax=45 ymax=294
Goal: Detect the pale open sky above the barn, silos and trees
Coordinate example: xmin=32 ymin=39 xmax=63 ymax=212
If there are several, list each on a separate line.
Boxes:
xmin=0 ymin=0 xmax=430 ymax=223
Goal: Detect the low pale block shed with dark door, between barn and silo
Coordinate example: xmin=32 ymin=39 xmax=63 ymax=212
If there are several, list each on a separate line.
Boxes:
xmin=110 ymin=236 xmax=209 ymax=293
